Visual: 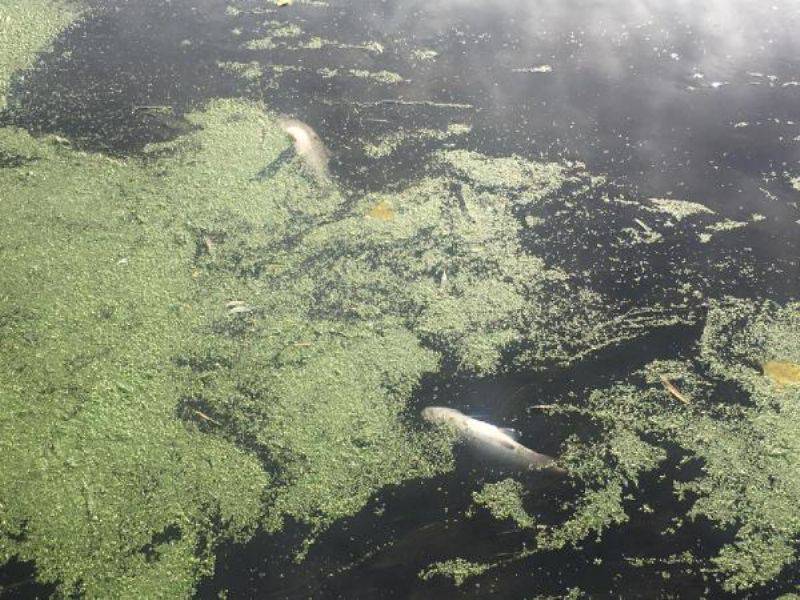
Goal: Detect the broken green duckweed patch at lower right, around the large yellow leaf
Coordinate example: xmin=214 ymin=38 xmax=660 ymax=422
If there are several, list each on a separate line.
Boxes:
xmin=446 ymin=298 xmax=800 ymax=592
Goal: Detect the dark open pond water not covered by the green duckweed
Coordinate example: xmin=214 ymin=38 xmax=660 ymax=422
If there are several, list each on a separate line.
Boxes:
xmin=0 ymin=0 xmax=800 ymax=598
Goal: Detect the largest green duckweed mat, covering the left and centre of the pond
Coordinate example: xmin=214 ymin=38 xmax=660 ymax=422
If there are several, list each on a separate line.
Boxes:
xmin=2 ymin=85 xmax=700 ymax=596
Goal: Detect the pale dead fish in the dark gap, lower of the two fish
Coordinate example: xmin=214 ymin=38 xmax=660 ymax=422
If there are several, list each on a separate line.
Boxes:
xmin=422 ymin=406 xmax=563 ymax=472
